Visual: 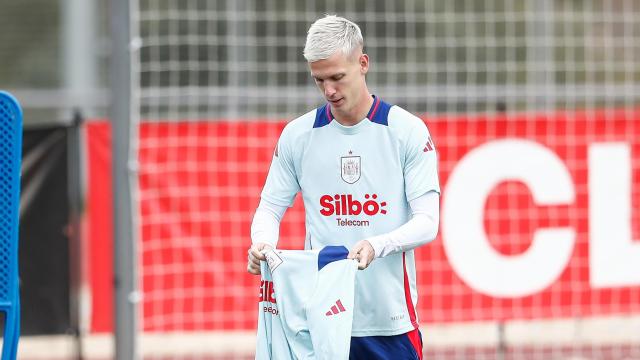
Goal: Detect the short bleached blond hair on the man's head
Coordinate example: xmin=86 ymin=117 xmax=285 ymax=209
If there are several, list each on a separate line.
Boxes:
xmin=303 ymin=15 xmax=364 ymax=62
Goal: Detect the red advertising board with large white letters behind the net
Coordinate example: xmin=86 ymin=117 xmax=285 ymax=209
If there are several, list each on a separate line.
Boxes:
xmin=87 ymin=109 xmax=640 ymax=332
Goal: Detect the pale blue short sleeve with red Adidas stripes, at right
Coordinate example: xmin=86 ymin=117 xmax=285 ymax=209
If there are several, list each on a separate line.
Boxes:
xmin=404 ymin=120 xmax=440 ymax=201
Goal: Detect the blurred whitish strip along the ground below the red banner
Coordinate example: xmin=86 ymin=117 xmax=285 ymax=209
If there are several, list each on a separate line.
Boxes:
xmin=13 ymin=315 xmax=640 ymax=360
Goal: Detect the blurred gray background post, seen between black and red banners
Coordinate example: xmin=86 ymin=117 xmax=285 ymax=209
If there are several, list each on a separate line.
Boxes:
xmin=59 ymin=0 xmax=98 ymax=359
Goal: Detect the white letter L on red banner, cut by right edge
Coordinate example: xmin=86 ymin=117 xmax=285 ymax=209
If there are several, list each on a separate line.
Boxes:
xmin=589 ymin=143 xmax=640 ymax=288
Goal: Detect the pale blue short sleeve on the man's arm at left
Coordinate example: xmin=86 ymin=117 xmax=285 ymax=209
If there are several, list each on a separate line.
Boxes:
xmin=261 ymin=128 xmax=300 ymax=206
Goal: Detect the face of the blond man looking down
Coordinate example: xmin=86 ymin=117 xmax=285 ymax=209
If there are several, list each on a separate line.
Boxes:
xmin=309 ymin=51 xmax=369 ymax=114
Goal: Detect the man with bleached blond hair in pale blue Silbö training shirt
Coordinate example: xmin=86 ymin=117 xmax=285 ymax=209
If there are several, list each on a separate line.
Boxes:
xmin=247 ymin=15 xmax=440 ymax=359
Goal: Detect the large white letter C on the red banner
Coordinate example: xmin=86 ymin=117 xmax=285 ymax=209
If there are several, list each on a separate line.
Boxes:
xmin=442 ymin=139 xmax=575 ymax=298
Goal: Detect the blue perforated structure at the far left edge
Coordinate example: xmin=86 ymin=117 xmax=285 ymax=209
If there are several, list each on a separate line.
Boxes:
xmin=0 ymin=91 xmax=22 ymax=360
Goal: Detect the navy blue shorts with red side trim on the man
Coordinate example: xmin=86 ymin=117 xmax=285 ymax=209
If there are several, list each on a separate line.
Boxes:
xmin=349 ymin=329 xmax=422 ymax=360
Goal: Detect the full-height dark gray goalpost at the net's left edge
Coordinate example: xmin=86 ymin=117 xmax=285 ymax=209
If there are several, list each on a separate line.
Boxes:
xmin=110 ymin=0 xmax=139 ymax=360
